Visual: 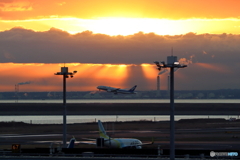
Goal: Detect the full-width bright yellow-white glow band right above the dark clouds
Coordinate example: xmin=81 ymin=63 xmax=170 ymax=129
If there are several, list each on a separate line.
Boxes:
xmin=0 ymin=17 xmax=240 ymax=36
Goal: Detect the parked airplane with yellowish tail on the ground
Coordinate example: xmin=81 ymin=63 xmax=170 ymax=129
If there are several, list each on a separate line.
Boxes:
xmin=81 ymin=120 xmax=153 ymax=149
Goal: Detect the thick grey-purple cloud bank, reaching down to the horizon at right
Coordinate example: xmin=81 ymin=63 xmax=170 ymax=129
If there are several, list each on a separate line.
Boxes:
xmin=0 ymin=28 xmax=240 ymax=89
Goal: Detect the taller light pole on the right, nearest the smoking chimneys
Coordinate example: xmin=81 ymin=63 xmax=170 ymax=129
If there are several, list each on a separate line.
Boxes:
xmin=154 ymin=56 xmax=187 ymax=160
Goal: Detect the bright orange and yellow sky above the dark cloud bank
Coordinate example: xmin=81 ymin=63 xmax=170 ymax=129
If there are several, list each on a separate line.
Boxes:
xmin=0 ymin=0 xmax=240 ymax=35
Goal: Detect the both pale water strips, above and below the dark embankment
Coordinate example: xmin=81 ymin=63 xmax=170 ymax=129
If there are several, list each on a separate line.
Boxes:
xmin=0 ymin=99 xmax=240 ymax=124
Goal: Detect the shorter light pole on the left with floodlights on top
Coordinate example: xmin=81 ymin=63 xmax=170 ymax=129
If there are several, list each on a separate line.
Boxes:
xmin=55 ymin=67 xmax=77 ymax=147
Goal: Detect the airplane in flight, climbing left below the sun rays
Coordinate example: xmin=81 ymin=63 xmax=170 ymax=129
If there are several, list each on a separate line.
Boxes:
xmin=97 ymin=85 xmax=137 ymax=94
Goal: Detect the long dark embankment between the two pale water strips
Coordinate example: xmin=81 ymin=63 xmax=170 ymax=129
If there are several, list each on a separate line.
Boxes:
xmin=0 ymin=103 xmax=240 ymax=115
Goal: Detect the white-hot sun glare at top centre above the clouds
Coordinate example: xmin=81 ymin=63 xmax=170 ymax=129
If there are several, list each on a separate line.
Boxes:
xmin=85 ymin=18 xmax=185 ymax=36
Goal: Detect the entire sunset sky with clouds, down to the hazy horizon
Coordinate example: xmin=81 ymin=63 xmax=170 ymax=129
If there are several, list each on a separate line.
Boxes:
xmin=0 ymin=0 xmax=240 ymax=92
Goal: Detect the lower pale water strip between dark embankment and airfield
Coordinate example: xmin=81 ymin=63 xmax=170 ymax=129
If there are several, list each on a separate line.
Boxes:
xmin=0 ymin=115 xmax=239 ymax=124
